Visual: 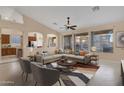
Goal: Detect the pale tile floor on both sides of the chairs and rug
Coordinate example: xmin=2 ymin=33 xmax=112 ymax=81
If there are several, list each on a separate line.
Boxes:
xmin=0 ymin=59 xmax=122 ymax=86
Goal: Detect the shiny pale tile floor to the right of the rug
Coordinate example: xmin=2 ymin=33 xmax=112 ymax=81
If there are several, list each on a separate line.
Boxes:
xmin=88 ymin=60 xmax=122 ymax=86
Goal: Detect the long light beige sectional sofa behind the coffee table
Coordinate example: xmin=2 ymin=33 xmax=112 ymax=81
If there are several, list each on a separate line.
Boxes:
xmin=36 ymin=54 xmax=90 ymax=64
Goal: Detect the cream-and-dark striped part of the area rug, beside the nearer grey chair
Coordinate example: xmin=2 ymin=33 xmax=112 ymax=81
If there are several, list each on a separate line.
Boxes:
xmin=45 ymin=63 xmax=97 ymax=86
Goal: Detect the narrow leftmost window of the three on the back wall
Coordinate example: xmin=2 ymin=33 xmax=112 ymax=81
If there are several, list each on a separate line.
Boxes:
xmin=64 ymin=35 xmax=72 ymax=49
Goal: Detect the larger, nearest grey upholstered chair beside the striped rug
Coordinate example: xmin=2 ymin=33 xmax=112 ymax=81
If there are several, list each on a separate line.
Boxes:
xmin=31 ymin=62 xmax=61 ymax=86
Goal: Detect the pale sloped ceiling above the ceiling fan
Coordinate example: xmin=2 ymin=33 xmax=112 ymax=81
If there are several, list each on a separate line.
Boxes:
xmin=12 ymin=6 xmax=124 ymax=32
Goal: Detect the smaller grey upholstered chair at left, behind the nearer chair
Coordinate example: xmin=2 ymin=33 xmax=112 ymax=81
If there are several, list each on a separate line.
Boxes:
xmin=19 ymin=58 xmax=32 ymax=81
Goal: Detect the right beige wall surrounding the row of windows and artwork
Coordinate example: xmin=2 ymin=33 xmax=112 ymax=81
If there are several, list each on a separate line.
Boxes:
xmin=61 ymin=22 xmax=124 ymax=61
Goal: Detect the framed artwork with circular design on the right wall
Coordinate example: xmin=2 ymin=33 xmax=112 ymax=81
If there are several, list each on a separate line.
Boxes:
xmin=116 ymin=31 xmax=124 ymax=48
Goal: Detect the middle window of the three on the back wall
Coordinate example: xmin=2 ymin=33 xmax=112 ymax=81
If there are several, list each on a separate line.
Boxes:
xmin=75 ymin=33 xmax=89 ymax=53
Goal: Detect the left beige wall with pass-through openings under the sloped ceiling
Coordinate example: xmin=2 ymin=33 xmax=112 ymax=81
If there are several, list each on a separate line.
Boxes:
xmin=0 ymin=16 xmax=59 ymax=57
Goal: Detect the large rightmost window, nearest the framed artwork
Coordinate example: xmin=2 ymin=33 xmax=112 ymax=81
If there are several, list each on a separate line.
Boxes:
xmin=91 ymin=30 xmax=113 ymax=53
